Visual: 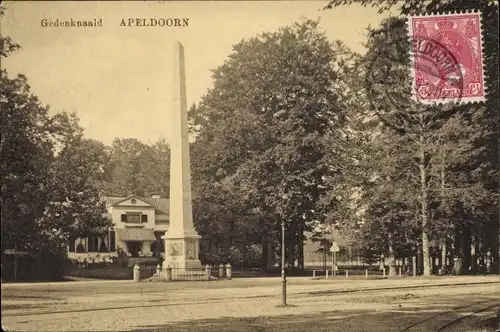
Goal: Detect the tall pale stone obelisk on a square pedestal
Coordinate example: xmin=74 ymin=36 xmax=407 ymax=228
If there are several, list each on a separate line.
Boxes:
xmin=163 ymin=42 xmax=201 ymax=269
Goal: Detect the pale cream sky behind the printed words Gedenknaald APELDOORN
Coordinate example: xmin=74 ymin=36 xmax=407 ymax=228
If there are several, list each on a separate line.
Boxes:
xmin=1 ymin=1 xmax=396 ymax=144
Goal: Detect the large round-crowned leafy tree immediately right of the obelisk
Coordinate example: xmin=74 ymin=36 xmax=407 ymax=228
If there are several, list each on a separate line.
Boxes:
xmin=189 ymin=20 xmax=354 ymax=264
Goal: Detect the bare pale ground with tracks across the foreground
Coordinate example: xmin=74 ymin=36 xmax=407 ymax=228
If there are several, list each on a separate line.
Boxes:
xmin=2 ymin=277 xmax=500 ymax=332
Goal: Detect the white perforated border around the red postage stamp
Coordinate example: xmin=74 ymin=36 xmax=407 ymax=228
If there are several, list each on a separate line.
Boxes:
xmin=406 ymin=10 xmax=488 ymax=105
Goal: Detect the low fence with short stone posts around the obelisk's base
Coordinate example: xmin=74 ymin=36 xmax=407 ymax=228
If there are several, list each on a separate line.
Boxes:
xmin=134 ymin=264 xmax=232 ymax=281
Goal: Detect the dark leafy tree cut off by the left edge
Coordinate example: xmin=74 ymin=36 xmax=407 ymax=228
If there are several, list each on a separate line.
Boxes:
xmin=0 ymin=70 xmax=53 ymax=250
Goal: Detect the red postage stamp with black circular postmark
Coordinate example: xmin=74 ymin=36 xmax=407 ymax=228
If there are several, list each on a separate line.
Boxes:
xmin=408 ymin=12 xmax=486 ymax=104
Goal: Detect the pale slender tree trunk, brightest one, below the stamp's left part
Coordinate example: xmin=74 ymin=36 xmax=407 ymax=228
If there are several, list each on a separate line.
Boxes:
xmin=419 ymin=135 xmax=432 ymax=276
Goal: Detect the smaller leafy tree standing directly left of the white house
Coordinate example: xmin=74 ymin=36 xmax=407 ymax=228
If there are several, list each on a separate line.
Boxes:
xmin=40 ymin=113 xmax=109 ymax=242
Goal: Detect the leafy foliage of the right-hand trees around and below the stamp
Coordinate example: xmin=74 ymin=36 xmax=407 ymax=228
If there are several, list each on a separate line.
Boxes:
xmin=327 ymin=0 xmax=498 ymax=273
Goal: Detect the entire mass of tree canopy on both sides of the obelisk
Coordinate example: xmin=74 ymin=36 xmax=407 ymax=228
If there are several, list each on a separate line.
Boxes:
xmin=0 ymin=0 xmax=500 ymax=275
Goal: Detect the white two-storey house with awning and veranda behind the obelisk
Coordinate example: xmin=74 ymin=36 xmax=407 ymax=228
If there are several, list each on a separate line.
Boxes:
xmin=68 ymin=195 xmax=169 ymax=259
